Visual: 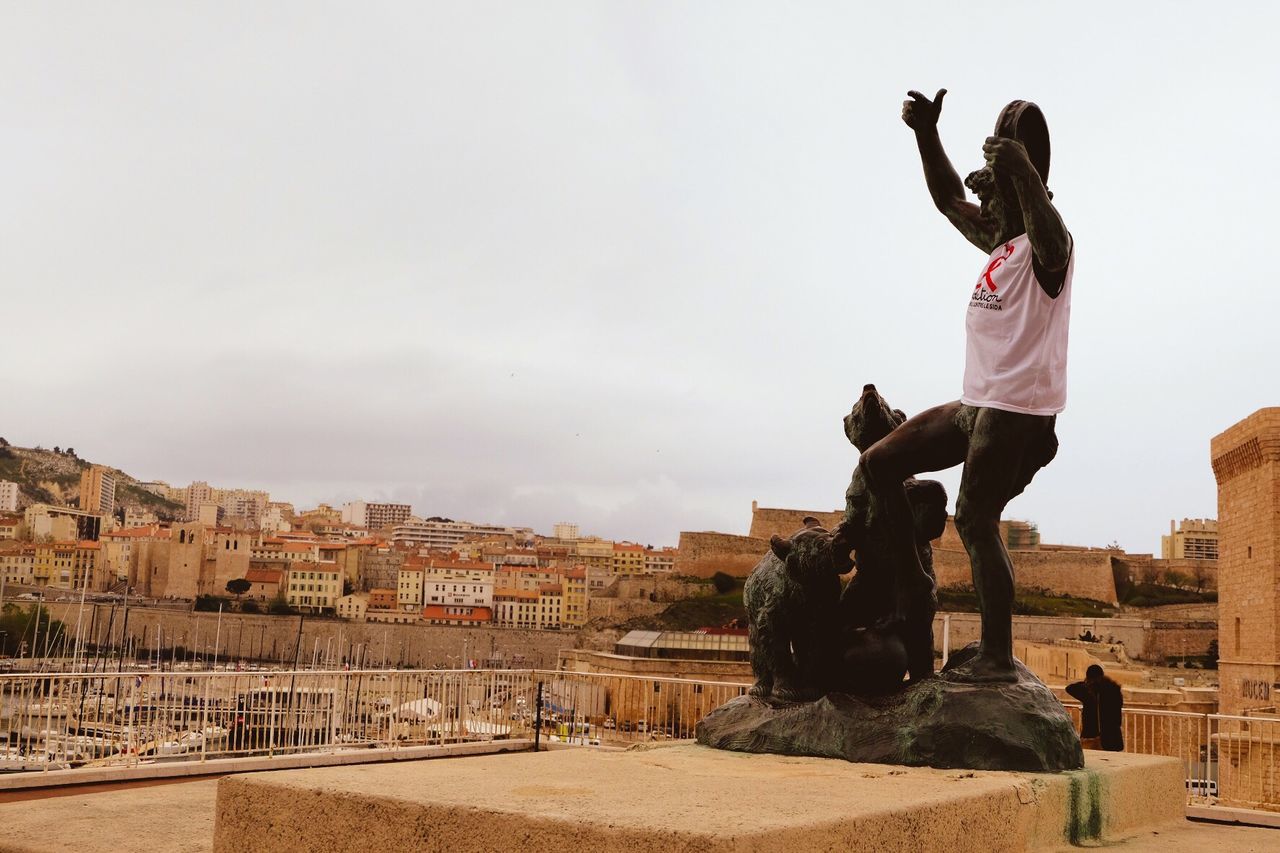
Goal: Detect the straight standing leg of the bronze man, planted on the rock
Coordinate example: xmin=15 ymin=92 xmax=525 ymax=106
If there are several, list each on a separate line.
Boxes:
xmin=954 ymin=409 xmax=1052 ymax=681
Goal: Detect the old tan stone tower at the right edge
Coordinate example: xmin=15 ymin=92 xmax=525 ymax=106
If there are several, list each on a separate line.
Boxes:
xmin=1210 ymin=407 xmax=1280 ymax=713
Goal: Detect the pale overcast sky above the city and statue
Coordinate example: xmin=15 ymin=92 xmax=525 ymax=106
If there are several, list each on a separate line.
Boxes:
xmin=0 ymin=0 xmax=1280 ymax=552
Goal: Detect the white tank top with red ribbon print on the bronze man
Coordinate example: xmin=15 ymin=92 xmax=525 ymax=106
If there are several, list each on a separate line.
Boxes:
xmin=960 ymin=234 xmax=1075 ymax=415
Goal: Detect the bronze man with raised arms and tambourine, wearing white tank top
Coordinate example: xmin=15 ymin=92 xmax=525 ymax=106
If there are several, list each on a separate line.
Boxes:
xmin=859 ymin=88 xmax=1074 ymax=681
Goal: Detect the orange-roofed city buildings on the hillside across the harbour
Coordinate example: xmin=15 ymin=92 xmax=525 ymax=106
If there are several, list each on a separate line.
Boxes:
xmin=0 ymin=494 xmax=676 ymax=629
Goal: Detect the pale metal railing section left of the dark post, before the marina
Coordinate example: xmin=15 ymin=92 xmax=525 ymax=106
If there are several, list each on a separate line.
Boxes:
xmin=0 ymin=670 xmax=534 ymax=771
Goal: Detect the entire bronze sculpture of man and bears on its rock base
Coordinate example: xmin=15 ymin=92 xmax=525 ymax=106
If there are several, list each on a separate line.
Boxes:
xmin=696 ymin=90 xmax=1084 ymax=771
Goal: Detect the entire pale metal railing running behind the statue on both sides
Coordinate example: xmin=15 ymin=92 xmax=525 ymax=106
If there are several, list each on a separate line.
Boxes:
xmin=0 ymin=670 xmax=1280 ymax=811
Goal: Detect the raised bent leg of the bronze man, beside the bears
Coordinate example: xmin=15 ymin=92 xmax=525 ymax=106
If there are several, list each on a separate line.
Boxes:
xmin=858 ymin=402 xmax=968 ymax=619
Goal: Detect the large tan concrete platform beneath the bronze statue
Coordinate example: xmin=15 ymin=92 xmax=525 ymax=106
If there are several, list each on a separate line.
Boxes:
xmin=214 ymin=743 xmax=1185 ymax=853
